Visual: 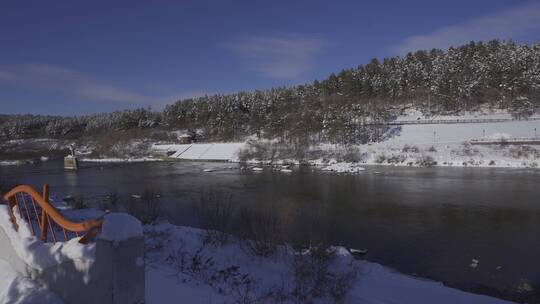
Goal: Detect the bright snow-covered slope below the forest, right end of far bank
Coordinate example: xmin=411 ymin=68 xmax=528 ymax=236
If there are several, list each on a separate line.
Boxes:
xmin=344 ymin=120 xmax=540 ymax=168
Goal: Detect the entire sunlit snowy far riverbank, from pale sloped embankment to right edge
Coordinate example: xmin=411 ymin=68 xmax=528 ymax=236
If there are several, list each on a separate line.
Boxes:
xmin=153 ymin=110 xmax=540 ymax=173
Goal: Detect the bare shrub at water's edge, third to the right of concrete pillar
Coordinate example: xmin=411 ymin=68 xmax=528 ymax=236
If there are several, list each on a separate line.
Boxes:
xmin=236 ymin=208 xmax=282 ymax=257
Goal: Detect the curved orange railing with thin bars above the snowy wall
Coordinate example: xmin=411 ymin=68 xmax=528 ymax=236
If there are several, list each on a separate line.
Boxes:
xmin=4 ymin=185 xmax=103 ymax=244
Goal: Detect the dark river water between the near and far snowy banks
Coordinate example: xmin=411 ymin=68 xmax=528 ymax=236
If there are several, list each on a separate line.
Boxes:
xmin=0 ymin=161 xmax=540 ymax=302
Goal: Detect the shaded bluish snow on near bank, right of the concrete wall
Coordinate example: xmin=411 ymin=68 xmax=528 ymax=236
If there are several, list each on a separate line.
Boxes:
xmin=145 ymin=223 xmax=509 ymax=304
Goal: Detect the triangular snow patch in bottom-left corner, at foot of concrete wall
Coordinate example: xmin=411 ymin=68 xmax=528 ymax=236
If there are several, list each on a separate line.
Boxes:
xmin=0 ymin=260 xmax=63 ymax=304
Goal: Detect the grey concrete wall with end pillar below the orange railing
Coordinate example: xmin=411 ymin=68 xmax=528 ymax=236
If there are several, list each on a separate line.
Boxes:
xmin=0 ymin=222 xmax=145 ymax=304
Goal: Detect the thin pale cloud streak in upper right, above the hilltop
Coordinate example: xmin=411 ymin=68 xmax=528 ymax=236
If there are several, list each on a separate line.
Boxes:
xmin=392 ymin=1 xmax=540 ymax=54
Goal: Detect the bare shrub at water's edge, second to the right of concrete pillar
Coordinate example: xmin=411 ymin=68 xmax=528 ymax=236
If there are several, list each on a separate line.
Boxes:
xmin=194 ymin=191 xmax=234 ymax=245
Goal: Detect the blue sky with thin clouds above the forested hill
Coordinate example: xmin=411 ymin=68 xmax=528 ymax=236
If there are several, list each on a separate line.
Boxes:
xmin=0 ymin=0 xmax=540 ymax=115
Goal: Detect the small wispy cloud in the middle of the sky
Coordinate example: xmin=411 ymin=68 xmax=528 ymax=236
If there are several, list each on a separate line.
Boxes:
xmin=225 ymin=35 xmax=326 ymax=79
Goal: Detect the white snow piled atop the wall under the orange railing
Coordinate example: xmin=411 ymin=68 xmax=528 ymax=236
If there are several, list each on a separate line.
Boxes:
xmin=0 ymin=205 xmax=95 ymax=271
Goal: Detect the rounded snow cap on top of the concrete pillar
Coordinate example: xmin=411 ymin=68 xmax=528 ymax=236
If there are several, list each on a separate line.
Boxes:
xmin=99 ymin=213 xmax=143 ymax=241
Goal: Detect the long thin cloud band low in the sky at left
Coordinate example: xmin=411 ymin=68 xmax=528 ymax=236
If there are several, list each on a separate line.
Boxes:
xmin=0 ymin=64 xmax=200 ymax=107
